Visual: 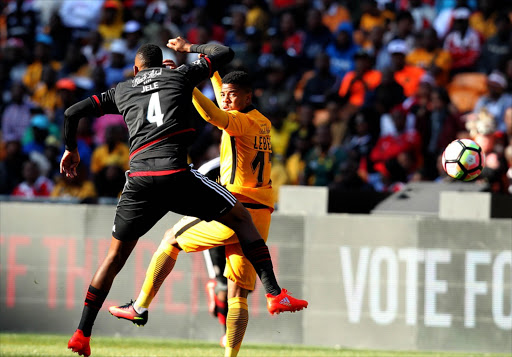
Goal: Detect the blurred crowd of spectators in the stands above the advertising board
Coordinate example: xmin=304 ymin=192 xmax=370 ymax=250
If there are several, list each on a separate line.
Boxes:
xmin=0 ymin=0 xmax=512 ymax=206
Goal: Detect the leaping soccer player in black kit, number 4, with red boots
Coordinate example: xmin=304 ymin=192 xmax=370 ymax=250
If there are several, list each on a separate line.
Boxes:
xmin=60 ymin=37 xmax=307 ymax=356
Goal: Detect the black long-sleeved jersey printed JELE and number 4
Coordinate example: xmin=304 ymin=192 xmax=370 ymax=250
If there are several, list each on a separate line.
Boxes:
xmin=65 ymin=44 xmax=233 ymax=172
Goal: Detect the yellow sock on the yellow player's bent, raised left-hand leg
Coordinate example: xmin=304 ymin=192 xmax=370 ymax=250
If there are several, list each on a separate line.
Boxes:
xmin=135 ymin=242 xmax=180 ymax=309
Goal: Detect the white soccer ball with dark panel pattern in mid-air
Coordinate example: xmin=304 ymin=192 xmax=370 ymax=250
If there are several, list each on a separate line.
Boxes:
xmin=442 ymin=139 xmax=485 ymax=181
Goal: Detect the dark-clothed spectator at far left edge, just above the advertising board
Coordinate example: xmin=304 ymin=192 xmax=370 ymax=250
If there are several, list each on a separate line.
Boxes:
xmin=0 ymin=140 xmax=28 ymax=195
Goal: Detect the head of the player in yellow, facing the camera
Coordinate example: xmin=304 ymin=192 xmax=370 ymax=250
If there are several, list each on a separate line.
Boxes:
xmin=221 ymin=71 xmax=252 ymax=110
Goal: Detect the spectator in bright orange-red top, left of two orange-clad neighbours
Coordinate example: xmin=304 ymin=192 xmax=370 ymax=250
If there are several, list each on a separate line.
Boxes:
xmin=338 ymin=50 xmax=382 ymax=108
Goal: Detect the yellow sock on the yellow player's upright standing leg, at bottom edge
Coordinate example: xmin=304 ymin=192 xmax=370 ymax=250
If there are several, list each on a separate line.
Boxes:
xmin=224 ymin=297 xmax=249 ymax=357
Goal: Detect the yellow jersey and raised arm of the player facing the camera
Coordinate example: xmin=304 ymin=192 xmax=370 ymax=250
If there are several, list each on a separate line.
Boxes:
xmin=193 ymin=72 xmax=274 ymax=208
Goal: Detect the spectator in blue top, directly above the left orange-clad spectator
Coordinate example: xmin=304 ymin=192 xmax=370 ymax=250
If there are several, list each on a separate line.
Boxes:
xmin=325 ymin=22 xmax=359 ymax=81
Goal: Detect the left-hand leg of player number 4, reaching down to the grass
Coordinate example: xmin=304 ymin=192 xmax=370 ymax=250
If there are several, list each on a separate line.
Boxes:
xmin=68 ymin=174 xmax=166 ymax=356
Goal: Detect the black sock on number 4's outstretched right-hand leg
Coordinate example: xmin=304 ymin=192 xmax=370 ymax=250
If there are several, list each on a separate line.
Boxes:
xmin=241 ymin=239 xmax=281 ymax=295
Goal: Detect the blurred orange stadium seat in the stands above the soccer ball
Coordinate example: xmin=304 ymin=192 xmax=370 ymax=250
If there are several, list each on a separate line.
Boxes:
xmin=447 ymin=72 xmax=487 ymax=113
